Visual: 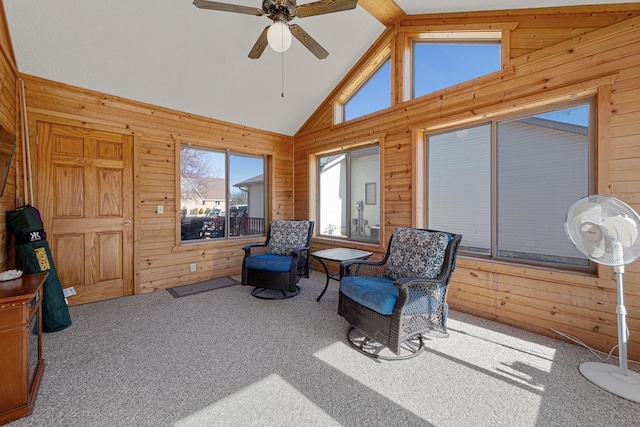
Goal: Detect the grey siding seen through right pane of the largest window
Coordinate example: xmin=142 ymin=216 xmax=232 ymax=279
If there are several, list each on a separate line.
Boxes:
xmin=497 ymin=118 xmax=589 ymax=261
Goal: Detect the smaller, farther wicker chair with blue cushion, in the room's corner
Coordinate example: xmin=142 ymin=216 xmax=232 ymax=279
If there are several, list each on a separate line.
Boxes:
xmin=242 ymin=219 xmax=314 ymax=299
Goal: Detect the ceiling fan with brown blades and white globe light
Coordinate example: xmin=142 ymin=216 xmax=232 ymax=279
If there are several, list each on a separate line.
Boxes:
xmin=193 ymin=0 xmax=358 ymax=59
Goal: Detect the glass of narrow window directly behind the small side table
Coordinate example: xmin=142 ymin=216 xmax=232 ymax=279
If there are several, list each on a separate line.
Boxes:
xmin=317 ymin=147 xmax=380 ymax=242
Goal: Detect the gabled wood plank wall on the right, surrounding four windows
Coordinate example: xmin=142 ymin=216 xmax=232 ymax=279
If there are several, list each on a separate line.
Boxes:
xmin=294 ymin=3 xmax=640 ymax=360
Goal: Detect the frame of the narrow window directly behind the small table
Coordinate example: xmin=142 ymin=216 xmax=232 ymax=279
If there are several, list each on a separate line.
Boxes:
xmin=311 ymin=144 xmax=384 ymax=246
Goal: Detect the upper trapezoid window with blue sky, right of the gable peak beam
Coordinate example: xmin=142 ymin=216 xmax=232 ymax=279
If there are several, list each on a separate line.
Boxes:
xmin=412 ymin=33 xmax=501 ymax=98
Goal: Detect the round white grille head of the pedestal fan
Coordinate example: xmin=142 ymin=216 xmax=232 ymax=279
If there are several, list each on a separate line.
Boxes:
xmin=565 ymin=194 xmax=640 ymax=266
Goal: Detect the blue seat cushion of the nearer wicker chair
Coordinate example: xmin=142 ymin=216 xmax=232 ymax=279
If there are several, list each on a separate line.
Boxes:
xmin=340 ymin=276 xmax=400 ymax=315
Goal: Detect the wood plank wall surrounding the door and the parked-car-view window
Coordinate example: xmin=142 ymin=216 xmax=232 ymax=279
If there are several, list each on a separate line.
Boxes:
xmin=21 ymin=74 xmax=293 ymax=293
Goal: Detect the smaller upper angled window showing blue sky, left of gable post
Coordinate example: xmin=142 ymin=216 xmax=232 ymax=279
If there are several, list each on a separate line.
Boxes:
xmin=343 ymin=59 xmax=391 ymax=121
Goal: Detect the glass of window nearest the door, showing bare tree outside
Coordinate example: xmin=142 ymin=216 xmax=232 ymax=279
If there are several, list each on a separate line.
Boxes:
xmin=180 ymin=144 xmax=266 ymax=241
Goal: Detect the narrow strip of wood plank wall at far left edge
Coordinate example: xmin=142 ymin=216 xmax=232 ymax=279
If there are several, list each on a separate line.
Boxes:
xmin=0 ymin=0 xmax=21 ymax=271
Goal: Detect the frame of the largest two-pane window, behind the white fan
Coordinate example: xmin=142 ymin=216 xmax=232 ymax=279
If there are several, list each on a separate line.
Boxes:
xmin=419 ymin=96 xmax=598 ymax=273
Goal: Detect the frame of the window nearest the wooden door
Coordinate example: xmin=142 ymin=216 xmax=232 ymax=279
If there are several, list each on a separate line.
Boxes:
xmin=174 ymin=142 xmax=271 ymax=249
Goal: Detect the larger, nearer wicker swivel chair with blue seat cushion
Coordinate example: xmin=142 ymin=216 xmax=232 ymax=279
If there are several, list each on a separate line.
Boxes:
xmin=338 ymin=227 xmax=462 ymax=360
